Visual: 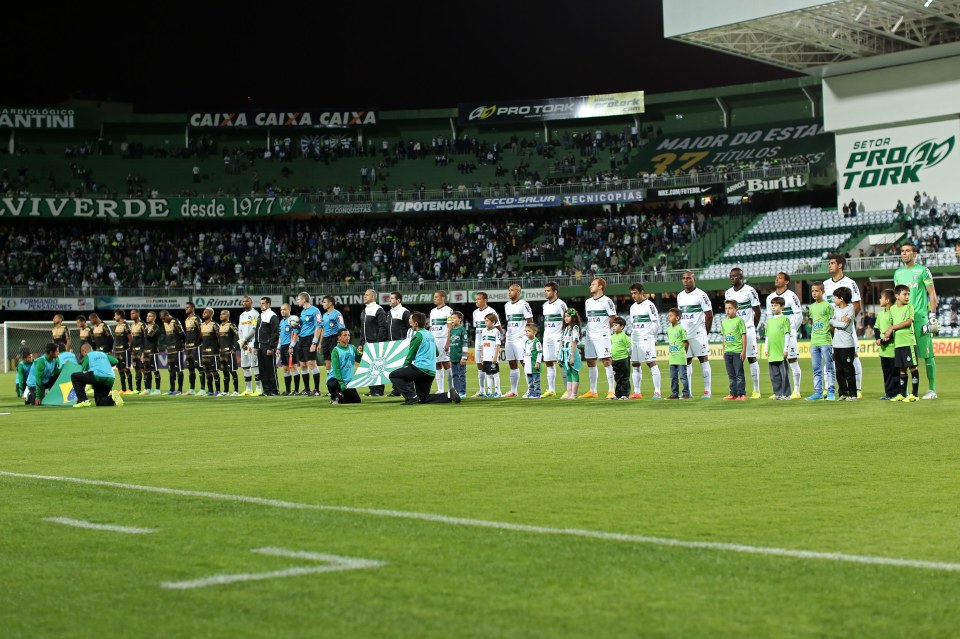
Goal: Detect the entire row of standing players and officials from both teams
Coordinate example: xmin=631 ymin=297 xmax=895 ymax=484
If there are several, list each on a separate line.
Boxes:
xmin=45 ymin=248 xmax=937 ymax=399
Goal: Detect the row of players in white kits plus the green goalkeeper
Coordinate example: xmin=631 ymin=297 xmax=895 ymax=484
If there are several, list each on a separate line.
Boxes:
xmin=450 ymin=249 xmax=937 ymax=399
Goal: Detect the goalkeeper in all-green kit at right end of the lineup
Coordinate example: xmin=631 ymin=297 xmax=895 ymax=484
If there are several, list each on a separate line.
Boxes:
xmin=893 ymin=242 xmax=940 ymax=399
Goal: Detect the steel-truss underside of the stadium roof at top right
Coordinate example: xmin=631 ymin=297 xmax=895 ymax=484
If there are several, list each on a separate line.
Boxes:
xmin=673 ymin=0 xmax=960 ymax=74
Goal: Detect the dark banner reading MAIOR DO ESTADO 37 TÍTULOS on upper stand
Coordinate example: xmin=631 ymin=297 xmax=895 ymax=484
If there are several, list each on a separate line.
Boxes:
xmin=626 ymin=121 xmax=834 ymax=175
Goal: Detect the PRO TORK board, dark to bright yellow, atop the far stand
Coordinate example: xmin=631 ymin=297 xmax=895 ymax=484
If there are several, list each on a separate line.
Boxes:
xmin=457 ymin=91 xmax=644 ymax=124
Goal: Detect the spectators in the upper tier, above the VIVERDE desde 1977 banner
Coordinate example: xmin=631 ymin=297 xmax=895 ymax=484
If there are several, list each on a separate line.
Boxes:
xmin=0 ymin=128 xmax=641 ymax=197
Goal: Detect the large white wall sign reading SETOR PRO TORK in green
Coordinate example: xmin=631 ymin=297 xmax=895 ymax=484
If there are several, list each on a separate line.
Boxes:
xmin=837 ymin=118 xmax=960 ymax=210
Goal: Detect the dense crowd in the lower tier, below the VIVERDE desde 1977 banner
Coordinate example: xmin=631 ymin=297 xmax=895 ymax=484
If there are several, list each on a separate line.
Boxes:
xmin=0 ymin=205 xmax=732 ymax=294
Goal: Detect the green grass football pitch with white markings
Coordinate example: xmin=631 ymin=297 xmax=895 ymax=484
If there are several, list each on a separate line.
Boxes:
xmin=0 ymin=358 xmax=960 ymax=638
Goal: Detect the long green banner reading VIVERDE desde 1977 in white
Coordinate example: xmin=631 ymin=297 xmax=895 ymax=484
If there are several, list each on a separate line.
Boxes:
xmin=0 ymin=197 xmax=307 ymax=220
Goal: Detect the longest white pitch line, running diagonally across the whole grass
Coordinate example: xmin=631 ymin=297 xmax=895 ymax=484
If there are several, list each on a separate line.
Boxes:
xmin=0 ymin=470 xmax=960 ymax=572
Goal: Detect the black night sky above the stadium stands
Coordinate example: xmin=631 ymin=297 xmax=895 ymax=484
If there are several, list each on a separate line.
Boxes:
xmin=0 ymin=0 xmax=796 ymax=113
